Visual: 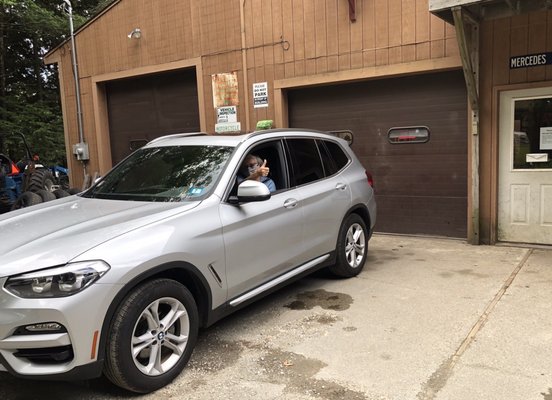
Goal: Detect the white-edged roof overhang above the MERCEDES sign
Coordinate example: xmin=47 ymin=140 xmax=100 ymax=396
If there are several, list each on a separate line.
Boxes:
xmin=429 ymin=0 xmax=552 ymax=24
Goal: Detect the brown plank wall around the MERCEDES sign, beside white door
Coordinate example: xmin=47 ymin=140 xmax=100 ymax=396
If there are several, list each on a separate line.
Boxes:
xmin=480 ymin=11 xmax=552 ymax=243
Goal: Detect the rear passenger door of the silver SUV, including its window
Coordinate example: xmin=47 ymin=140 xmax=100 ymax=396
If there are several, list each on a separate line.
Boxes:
xmin=286 ymin=138 xmax=351 ymax=260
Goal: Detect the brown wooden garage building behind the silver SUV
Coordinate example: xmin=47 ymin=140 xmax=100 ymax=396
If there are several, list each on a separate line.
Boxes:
xmin=46 ymin=0 xmax=552 ymax=244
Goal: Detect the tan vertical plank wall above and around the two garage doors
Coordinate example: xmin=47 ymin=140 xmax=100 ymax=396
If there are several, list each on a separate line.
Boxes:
xmin=51 ymin=0 xmax=458 ymax=185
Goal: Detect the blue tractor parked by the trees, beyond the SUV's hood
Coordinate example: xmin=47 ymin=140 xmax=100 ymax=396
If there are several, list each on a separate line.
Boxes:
xmin=0 ymin=133 xmax=69 ymax=213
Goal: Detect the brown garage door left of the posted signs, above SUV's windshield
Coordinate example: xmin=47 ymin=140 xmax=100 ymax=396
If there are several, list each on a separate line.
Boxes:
xmin=106 ymin=69 xmax=200 ymax=164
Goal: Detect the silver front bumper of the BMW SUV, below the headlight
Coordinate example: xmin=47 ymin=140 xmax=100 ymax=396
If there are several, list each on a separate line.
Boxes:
xmin=0 ymin=278 xmax=120 ymax=379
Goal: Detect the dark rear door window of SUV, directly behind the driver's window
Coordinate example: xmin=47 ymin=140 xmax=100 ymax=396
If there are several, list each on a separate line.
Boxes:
xmin=287 ymin=139 xmax=324 ymax=186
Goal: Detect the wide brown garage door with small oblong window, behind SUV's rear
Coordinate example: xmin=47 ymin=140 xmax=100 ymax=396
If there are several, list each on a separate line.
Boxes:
xmin=288 ymin=71 xmax=467 ymax=238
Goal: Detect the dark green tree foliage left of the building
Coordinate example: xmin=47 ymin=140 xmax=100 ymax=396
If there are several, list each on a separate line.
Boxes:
xmin=0 ymin=0 xmax=113 ymax=164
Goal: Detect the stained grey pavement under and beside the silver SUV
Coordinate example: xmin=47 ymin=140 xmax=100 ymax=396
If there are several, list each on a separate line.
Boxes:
xmin=0 ymin=235 xmax=552 ymax=400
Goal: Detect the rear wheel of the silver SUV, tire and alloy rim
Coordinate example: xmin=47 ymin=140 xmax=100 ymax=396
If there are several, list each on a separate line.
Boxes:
xmin=329 ymin=214 xmax=369 ymax=278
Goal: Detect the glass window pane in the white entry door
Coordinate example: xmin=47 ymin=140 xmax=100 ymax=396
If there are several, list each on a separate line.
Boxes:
xmin=513 ymin=97 xmax=552 ymax=169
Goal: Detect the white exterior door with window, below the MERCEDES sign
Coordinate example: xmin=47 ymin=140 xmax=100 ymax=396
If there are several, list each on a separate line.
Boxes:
xmin=498 ymin=87 xmax=552 ymax=244
